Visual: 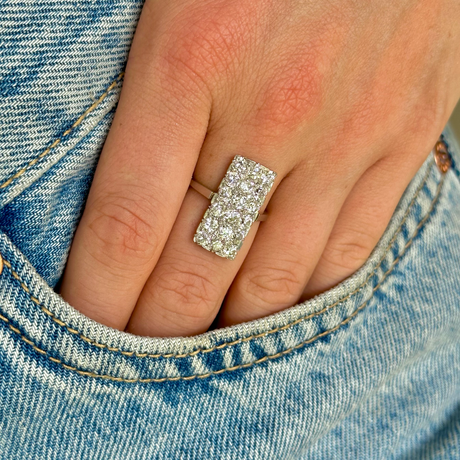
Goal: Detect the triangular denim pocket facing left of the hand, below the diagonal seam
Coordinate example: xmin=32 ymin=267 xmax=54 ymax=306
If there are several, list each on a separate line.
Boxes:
xmin=0 ymin=76 xmax=121 ymax=286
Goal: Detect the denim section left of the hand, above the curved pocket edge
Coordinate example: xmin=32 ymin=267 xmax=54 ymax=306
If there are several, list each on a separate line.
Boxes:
xmin=0 ymin=0 xmax=138 ymax=285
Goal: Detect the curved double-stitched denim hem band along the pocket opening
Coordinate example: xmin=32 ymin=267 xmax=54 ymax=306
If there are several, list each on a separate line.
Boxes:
xmin=0 ymin=140 xmax=452 ymax=383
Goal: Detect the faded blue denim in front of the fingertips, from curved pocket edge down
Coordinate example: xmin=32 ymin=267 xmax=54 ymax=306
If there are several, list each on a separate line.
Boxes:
xmin=0 ymin=130 xmax=460 ymax=460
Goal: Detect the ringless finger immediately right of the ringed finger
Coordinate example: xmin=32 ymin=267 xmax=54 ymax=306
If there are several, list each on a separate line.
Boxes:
xmin=218 ymin=159 xmax=360 ymax=327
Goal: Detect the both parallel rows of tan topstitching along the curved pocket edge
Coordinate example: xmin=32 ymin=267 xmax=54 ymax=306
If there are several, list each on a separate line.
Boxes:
xmin=0 ymin=161 xmax=446 ymax=383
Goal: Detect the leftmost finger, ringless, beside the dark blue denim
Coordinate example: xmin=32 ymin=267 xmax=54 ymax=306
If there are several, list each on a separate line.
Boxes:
xmin=61 ymin=3 xmax=210 ymax=329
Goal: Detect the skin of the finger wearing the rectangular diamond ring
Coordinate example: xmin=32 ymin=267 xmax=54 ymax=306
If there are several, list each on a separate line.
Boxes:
xmin=127 ymin=145 xmax=286 ymax=336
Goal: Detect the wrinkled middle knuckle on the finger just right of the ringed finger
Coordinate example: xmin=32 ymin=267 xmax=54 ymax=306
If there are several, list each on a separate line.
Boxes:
xmin=242 ymin=263 xmax=305 ymax=307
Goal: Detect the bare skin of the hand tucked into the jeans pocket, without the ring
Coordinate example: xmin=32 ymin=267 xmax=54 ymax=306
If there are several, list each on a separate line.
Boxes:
xmin=61 ymin=0 xmax=460 ymax=337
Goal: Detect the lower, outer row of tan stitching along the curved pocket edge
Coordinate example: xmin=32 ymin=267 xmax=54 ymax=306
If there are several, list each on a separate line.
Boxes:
xmin=0 ymin=175 xmax=445 ymax=383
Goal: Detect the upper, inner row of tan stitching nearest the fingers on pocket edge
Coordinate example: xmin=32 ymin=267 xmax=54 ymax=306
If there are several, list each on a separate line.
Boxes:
xmin=3 ymin=159 xmax=435 ymax=359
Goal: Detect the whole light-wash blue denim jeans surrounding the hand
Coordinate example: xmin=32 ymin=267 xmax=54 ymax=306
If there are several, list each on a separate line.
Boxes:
xmin=0 ymin=0 xmax=460 ymax=460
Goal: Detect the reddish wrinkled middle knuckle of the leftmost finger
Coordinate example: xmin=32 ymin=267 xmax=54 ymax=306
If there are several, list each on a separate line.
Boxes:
xmin=88 ymin=196 xmax=159 ymax=265
